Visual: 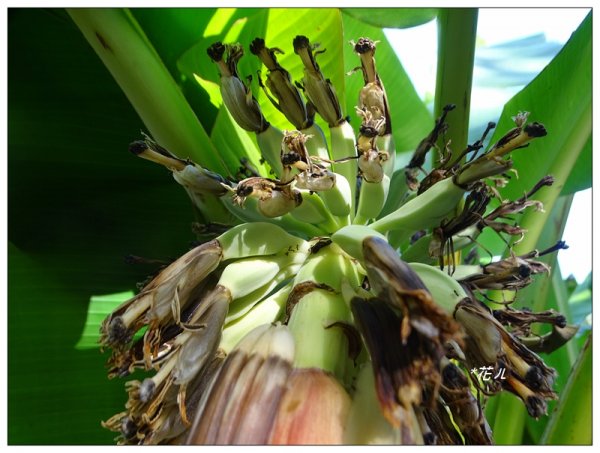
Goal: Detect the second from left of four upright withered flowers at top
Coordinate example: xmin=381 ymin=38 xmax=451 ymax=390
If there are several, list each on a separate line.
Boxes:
xmin=250 ymin=38 xmax=313 ymax=129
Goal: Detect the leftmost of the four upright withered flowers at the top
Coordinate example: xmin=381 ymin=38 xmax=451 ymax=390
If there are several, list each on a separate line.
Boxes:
xmin=207 ymin=42 xmax=269 ymax=133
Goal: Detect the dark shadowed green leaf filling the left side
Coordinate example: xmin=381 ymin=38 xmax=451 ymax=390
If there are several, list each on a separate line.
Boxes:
xmin=7 ymin=9 xmax=199 ymax=444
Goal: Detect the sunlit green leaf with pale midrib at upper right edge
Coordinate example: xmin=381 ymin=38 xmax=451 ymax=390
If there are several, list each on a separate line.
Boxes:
xmin=481 ymin=16 xmax=592 ymax=262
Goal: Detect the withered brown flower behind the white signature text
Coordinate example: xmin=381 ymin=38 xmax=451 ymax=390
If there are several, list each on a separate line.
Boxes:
xmin=454 ymin=298 xmax=557 ymax=418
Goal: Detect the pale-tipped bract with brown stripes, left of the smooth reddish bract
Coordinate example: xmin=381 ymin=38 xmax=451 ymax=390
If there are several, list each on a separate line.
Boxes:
xmin=187 ymin=325 xmax=294 ymax=445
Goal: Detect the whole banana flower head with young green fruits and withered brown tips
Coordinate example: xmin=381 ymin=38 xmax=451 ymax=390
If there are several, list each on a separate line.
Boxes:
xmin=100 ymin=31 xmax=574 ymax=444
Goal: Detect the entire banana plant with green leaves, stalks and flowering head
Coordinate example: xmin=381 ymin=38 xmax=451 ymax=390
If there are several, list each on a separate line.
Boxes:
xmin=8 ymin=9 xmax=591 ymax=444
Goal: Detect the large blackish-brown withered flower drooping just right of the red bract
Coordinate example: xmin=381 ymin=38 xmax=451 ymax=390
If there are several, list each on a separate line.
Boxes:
xmin=351 ymin=236 xmax=461 ymax=444
